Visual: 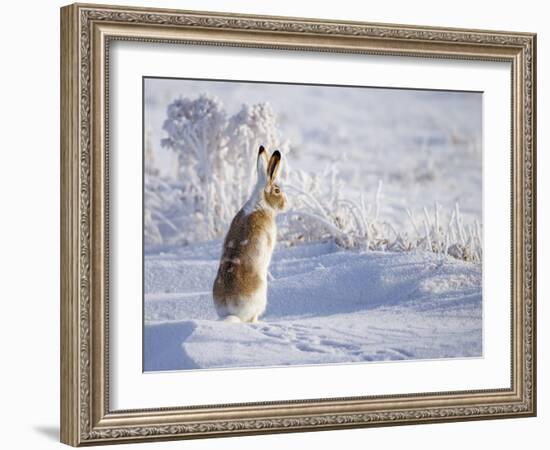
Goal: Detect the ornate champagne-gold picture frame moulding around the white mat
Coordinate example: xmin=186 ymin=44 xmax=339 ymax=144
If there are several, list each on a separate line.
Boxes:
xmin=61 ymin=4 xmax=536 ymax=446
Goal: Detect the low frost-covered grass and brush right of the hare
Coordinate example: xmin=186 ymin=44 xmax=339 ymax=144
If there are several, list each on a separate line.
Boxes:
xmin=279 ymin=173 xmax=482 ymax=262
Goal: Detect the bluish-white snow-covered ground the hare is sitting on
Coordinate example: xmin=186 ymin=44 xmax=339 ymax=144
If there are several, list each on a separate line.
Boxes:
xmin=144 ymin=241 xmax=482 ymax=371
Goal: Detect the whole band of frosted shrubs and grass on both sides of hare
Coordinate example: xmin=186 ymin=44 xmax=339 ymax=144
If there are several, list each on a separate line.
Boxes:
xmin=144 ymin=94 xmax=482 ymax=262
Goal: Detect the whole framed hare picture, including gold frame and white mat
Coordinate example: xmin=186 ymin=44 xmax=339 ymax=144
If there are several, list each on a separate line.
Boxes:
xmin=61 ymin=4 xmax=536 ymax=446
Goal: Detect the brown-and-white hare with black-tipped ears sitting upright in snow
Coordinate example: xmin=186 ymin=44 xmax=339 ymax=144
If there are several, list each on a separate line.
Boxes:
xmin=212 ymin=146 xmax=286 ymax=322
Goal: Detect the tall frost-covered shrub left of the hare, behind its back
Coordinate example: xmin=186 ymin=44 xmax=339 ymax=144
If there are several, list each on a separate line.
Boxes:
xmin=149 ymin=95 xmax=287 ymax=245
